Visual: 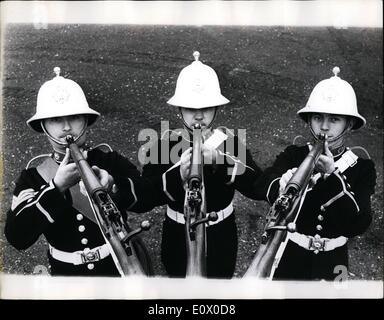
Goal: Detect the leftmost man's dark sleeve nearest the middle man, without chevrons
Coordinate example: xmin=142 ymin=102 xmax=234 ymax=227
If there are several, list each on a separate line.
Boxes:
xmin=88 ymin=150 xmax=158 ymax=212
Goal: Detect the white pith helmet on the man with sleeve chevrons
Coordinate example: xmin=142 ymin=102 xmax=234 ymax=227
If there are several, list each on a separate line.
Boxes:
xmin=27 ymin=67 xmax=100 ymax=132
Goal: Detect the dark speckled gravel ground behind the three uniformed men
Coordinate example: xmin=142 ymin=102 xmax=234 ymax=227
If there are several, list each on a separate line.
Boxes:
xmin=0 ymin=25 xmax=384 ymax=280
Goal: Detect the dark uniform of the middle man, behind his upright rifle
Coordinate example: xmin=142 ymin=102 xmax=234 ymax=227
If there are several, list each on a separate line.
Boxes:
xmin=143 ymin=131 xmax=261 ymax=278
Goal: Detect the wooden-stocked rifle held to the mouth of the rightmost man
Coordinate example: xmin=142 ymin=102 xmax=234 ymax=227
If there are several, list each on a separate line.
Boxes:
xmin=244 ymin=135 xmax=326 ymax=278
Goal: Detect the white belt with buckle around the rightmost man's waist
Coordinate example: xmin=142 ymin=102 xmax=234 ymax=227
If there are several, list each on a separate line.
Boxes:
xmin=288 ymin=232 xmax=348 ymax=254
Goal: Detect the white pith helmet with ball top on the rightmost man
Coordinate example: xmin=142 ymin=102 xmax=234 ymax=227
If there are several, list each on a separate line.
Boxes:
xmin=297 ymin=67 xmax=366 ymax=130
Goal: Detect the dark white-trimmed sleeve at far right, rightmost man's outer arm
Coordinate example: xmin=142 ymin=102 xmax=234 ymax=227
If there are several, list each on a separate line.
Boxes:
xmin=316 ymin=160 xmax=376 ymax=237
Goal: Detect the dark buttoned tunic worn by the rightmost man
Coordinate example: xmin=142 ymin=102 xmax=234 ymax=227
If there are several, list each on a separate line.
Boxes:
xmin=255 ymin=146 xmax=376 ymax=280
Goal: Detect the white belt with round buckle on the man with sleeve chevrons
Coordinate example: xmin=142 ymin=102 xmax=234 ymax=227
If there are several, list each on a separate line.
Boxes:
xmin=49 ymin=244 xmax=110 ymax=265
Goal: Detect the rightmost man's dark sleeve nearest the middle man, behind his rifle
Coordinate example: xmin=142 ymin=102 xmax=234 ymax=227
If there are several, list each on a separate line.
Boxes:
xmin=252 ymin=146 xmax=298 ymax=204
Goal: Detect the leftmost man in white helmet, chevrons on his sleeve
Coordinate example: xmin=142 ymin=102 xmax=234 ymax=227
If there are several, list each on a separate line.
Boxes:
xmin=4 ymin=67 xmax=157 ymax=277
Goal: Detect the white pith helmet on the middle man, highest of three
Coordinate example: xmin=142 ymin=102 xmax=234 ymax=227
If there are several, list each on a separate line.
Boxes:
xmin=168 ymin=51 xmax=229 ymax=109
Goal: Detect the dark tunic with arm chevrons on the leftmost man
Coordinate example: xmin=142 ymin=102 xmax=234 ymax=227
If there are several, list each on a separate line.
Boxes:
xmin=5 ymin=149 xmax=155 ymax=276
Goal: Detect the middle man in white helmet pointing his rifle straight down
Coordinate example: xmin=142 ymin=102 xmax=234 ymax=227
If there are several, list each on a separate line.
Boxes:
xmin=142 ymin=52 xmax=261 ymax=279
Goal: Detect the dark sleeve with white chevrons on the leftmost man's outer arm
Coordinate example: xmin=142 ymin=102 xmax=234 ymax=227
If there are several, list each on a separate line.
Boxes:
xmin=4 ymin=170 xmax=73 ymax=250
